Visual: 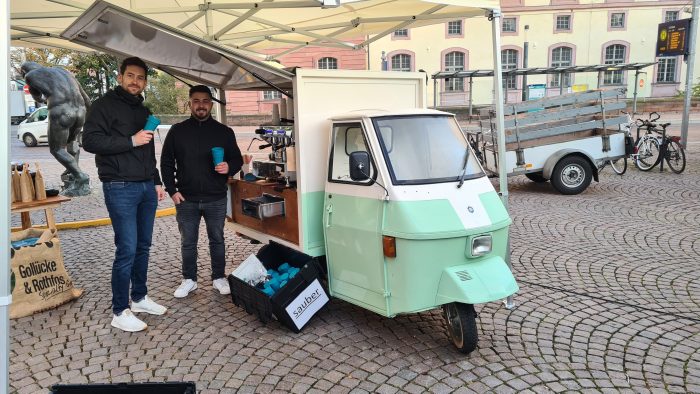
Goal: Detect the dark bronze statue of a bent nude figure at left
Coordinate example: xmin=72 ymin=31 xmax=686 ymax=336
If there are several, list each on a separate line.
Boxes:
xmin=21 ymin=62 xmax=90 ymax=196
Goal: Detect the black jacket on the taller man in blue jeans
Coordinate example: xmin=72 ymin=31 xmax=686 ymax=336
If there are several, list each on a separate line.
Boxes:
xmin=83 ymin=86 xmax=161 ymax=185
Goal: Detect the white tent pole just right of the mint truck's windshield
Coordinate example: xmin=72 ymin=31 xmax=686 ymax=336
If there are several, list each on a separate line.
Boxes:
xmin=491 ymin=10 xmax=515 ymax=309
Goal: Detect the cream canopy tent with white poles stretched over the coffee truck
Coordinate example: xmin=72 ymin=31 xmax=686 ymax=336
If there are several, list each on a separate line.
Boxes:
xmin=0 ymin=0 xmax=510 ymax=391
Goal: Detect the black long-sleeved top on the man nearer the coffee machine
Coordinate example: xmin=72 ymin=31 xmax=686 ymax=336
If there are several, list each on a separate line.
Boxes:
xmin=160 ymin=117 xmax=243 ymax=202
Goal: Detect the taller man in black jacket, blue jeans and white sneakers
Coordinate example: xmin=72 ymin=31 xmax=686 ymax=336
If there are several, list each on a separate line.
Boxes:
xmin=83 ymin=57 xmax=167 ymax=332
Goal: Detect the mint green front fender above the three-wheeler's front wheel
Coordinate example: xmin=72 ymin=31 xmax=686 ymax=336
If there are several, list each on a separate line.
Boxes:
xmin=435 ymin=256 xmax=519 ymax=305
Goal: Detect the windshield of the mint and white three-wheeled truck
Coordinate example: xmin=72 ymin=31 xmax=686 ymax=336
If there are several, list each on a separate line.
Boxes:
xmin=373 ymin=115 xmax=485 ymax=185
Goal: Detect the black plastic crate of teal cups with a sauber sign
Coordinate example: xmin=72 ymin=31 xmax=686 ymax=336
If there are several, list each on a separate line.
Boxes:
xmin=228 ymin=241 xmax=325 ymax=333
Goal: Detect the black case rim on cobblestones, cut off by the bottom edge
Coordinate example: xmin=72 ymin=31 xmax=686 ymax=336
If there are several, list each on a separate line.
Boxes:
xmin=49 ymin=382 xmax=197 ymax=394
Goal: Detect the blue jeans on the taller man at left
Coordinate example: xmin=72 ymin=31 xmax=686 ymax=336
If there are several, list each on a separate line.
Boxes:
xmin=102 ymin=181 xmax=158 ymax=315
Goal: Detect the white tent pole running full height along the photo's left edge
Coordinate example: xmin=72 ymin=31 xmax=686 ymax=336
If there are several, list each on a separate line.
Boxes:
xmin=0 ymin=1 xmax=12 ymax=393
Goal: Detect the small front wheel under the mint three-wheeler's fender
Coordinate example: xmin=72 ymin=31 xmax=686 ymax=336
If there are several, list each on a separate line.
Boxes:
xmin=442 ymin=302 xmax=479 ymax=354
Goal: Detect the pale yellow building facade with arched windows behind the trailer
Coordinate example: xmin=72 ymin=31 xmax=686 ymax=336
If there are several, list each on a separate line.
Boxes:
xmin=369 ymin=0 xmax=700 ymax=106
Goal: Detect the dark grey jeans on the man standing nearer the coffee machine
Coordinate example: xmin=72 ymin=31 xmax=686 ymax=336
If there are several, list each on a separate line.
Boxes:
xmin=175 ymin=198 xmax=226 ymax=281
